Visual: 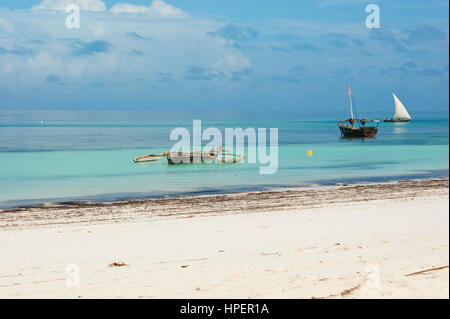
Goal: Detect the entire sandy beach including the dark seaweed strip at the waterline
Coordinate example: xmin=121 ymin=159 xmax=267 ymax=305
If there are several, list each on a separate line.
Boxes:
xmin=0 ymin=178 xmax=449 ymax=298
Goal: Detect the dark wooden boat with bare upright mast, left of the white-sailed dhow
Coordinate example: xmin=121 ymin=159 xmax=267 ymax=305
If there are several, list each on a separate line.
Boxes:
xmin=338 ymin=85 xmax=380 ymax=137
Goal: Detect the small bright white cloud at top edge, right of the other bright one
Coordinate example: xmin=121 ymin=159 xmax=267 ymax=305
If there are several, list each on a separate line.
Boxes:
xmin=110 ymin=0 xmax=189 ymax=18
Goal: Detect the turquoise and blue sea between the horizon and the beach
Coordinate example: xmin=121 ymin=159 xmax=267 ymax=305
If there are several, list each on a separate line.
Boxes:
xmin=0 ymin=111 xmax=449 ymax=207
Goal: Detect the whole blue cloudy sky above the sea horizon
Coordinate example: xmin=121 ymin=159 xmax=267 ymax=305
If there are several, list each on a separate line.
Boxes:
xmin=0 ymin=0 xmax=449 ymax=113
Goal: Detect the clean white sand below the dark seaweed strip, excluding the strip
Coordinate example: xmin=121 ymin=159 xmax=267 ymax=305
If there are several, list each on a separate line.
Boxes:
xmin=0 ymin=193 xmax=449 ymax=298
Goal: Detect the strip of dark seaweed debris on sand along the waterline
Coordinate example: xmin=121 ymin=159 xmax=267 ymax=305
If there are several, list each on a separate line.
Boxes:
xmin=0 ymin=178 xmax=449 ymax=229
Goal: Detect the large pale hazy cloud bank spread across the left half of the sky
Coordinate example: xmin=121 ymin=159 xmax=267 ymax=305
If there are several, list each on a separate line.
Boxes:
xmin=0 ymin=4 xmax=250 ymax=92
